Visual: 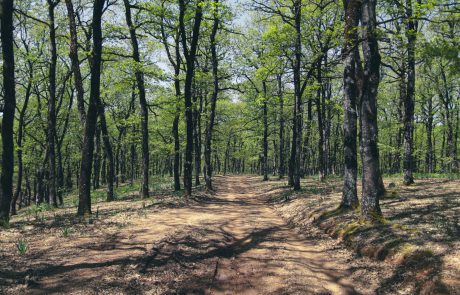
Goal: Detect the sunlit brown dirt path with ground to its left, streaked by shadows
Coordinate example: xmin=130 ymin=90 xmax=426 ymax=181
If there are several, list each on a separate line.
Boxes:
xmin=0 ymin=176 xmax=450 ymax=294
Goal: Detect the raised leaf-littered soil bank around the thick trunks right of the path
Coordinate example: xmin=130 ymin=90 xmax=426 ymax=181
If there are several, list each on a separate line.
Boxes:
xmin=270 ymin=178 xmax=460 ymax=294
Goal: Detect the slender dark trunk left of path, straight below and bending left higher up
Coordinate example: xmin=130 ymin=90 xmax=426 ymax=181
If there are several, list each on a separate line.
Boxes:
xmin=124 ymin=0 xmax=149 ymax=198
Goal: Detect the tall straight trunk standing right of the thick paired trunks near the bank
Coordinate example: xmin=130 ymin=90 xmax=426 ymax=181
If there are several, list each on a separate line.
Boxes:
xmin=403 ymin=0 xmax=417 ymax=185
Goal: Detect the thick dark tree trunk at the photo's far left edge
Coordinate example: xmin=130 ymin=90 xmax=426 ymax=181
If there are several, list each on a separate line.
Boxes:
xmin=0 ymin=0 xmax=16 ymax=226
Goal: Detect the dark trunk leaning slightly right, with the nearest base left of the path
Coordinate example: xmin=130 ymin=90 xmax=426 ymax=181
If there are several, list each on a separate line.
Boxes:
xmin=77 ymin=0 xmax=105 ymax=216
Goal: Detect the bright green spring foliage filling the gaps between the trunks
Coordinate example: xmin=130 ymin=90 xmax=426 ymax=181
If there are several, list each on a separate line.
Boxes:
xmin=4 ymin=0 xmax=460 ymax=220
